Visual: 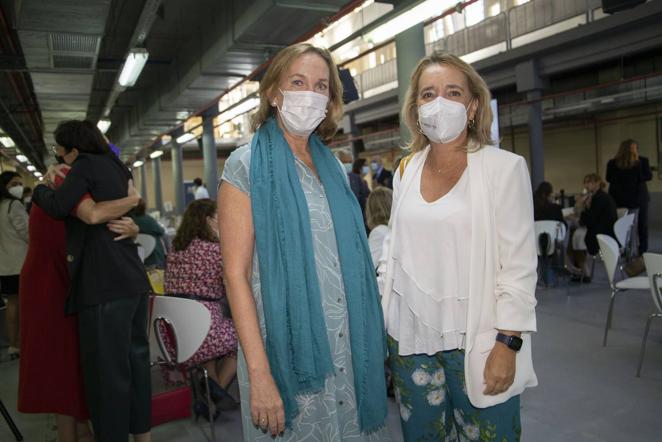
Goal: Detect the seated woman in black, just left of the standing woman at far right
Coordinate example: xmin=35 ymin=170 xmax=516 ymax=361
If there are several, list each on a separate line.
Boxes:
xmin=576 ymin=173 xmax=618 ymax=255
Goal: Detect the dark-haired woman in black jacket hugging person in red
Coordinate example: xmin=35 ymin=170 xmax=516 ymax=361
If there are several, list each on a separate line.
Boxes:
xmin=33 ymin=120 xmax=151 ymax=442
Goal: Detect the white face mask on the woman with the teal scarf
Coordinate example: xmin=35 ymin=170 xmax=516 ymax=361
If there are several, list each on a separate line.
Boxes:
xmin=278 ymin=89 xmax=329 ymax=137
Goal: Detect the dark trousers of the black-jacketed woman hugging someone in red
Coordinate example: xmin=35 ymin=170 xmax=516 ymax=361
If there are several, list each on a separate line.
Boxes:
xmin=78 ymin=295 xmax=152 ymax=442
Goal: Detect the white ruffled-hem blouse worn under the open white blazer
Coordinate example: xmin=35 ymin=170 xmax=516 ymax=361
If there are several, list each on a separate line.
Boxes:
xmin=385 ymin=153 xmax=471 ymax=355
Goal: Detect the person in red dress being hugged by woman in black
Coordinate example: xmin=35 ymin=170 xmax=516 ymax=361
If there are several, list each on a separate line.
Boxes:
xmin=18 ymin=165 xmax=140 ymax=442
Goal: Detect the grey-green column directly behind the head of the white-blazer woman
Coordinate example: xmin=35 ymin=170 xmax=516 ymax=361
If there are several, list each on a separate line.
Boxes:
xmin=395 ymin=23 xmax=425 ymax=142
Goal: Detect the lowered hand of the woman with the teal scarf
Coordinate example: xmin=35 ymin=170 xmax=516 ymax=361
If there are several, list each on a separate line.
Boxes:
xmin=250 ymin=373 xmax=285 ymax=437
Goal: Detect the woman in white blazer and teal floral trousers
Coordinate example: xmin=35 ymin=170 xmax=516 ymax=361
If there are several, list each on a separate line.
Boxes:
xmin=378 ymin=53 xmax=537 ymax=441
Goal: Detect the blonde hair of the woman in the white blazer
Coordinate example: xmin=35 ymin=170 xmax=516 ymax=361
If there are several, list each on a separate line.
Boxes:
xmin=402 ymin=51 xmax=493 ymax=152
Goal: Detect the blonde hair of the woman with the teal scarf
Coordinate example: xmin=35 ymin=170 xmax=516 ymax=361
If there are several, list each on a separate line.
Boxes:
xmin=251 ymin=43 xmax=343 ymax=141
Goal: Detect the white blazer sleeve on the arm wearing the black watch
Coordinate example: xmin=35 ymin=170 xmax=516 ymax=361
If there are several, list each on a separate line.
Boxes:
xmin=494 ymin=157 xmax=538 ymax=332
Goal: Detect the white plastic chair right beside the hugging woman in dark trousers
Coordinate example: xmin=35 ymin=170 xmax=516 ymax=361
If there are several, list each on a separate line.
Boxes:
xmin=150 ymin=296 xmax=216 ymax=441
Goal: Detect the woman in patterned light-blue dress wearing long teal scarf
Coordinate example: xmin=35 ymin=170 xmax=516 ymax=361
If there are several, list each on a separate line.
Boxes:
xmin=218 ymin=43 xmax=389 ymax=441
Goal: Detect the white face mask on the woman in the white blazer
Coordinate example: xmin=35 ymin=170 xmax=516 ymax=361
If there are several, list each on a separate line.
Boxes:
xmin=418 ymin=97 xmax=467 ymax=143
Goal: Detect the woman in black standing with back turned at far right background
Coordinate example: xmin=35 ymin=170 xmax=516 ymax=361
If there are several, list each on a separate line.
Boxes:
xmin=607 ymin=139 xmax=653 ymax=254
